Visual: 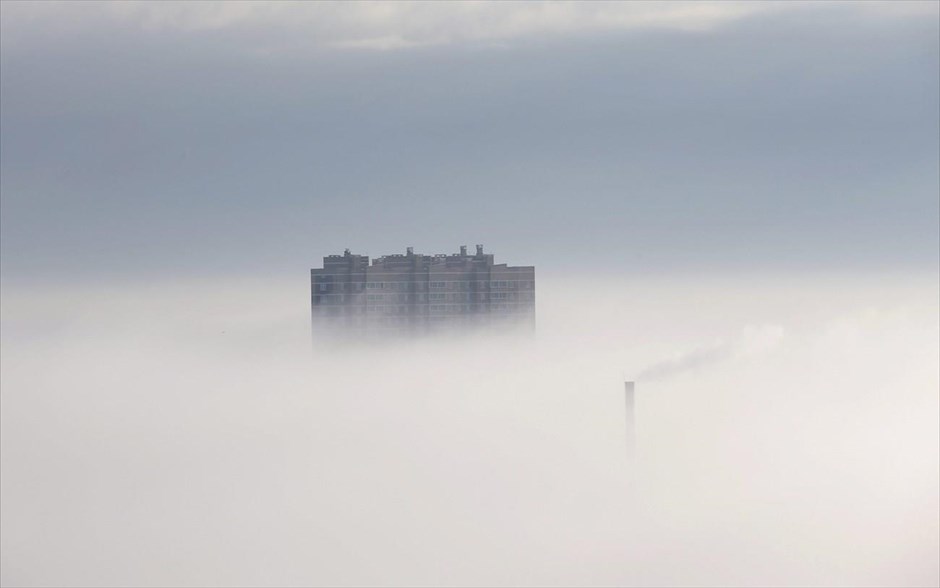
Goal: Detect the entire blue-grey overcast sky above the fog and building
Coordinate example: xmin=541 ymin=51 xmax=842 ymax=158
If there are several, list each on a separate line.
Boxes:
xmin=0 ymin=2 xmax=940 ymax=278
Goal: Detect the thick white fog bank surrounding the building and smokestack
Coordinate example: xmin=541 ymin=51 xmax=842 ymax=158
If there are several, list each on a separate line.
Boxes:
xmin=0 ymin=272 xmax=940 ymax=586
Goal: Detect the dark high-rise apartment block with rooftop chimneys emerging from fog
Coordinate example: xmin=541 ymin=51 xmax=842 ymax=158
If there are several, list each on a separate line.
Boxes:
xmin=310 ymin=245 xmax=535 ymax=336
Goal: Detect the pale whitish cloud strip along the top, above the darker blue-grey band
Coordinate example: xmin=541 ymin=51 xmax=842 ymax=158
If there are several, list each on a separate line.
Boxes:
xmin=4 ymin=1 xmax=836 ymax=55
